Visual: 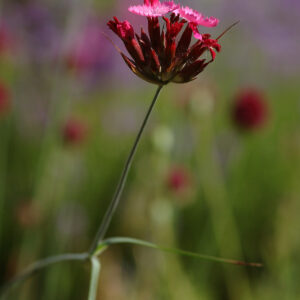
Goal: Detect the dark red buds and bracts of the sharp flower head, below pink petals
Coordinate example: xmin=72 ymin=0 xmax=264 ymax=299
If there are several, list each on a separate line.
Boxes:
xmin=107 ymin=13 xmax=221 ymax=85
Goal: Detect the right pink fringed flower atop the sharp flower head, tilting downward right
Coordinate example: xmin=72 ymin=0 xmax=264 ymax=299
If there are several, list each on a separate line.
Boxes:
xmin=174 ymin=6 xmax=219 ymax=27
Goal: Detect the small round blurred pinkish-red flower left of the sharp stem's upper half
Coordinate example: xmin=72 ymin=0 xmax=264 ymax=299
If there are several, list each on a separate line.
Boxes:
xmin=63 ymin=119 xmax=87 ymax=144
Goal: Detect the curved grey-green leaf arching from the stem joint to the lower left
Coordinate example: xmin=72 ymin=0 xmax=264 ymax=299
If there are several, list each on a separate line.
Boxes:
xmin=0 ymin=253 xmax=89 ymax=297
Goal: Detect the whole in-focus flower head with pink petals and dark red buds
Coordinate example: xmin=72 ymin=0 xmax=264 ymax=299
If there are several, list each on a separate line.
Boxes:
xmin=107 ymin=0 xmax=221 ymax=85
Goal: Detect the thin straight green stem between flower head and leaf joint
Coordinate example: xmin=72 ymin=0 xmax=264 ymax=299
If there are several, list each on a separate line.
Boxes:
xmin=89 ymin=86 xmax=162 ymax=255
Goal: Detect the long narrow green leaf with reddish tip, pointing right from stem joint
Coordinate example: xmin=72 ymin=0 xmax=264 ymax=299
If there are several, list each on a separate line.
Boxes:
xmin=97 ymin=237 xmax=263 ymax=267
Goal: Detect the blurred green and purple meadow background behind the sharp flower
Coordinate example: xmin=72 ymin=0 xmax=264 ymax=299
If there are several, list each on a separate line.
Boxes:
xmin=0 ymin=0 xmax=300 ymax=300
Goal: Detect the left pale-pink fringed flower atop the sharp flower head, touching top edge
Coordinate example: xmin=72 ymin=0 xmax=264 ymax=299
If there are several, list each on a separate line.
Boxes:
xmin=128 ymin=1 xmax=178 ymax=17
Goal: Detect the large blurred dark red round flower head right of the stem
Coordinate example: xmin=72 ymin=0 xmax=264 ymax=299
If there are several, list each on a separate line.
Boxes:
xmin=232 ymin=89 xmax=267 ymax=129
